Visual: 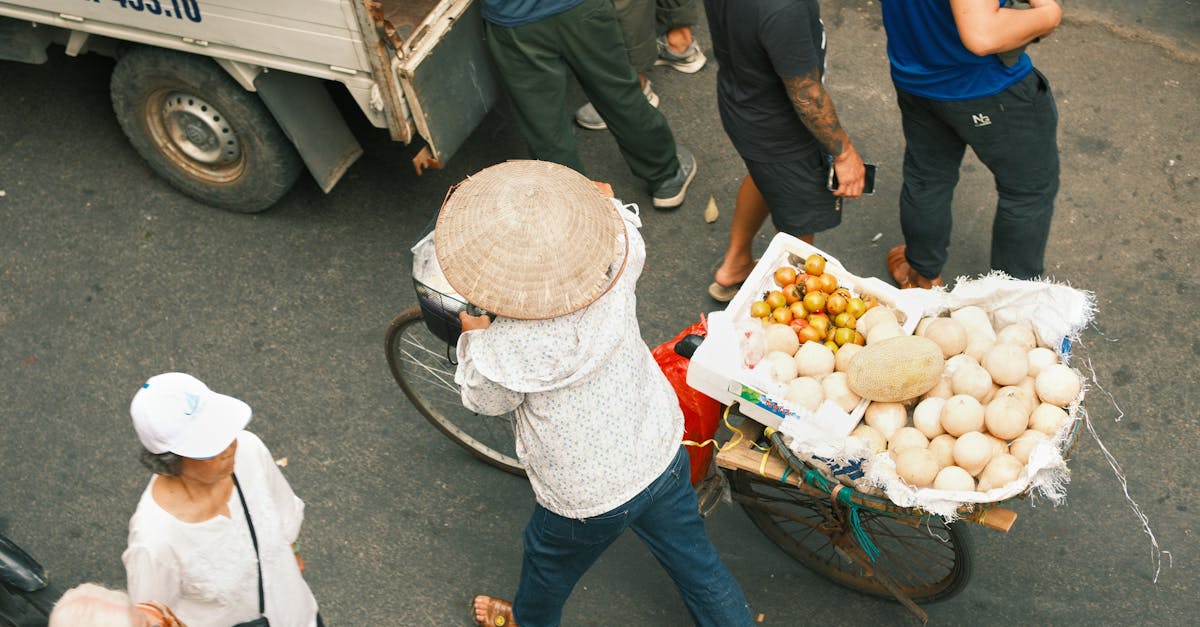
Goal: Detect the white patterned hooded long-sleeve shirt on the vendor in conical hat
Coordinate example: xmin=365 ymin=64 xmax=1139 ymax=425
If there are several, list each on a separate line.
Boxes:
xmin=455 ymin=205 xmax=683 ymax=519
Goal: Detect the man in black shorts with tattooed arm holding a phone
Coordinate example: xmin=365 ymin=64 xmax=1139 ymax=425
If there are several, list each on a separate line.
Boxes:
xmin=704 ymin=0 xmax=865 ymax=301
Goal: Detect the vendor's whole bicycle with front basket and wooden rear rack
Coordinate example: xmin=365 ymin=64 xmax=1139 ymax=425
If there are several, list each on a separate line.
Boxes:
xmin=385 ymin=279 xmax=1082 ymax=622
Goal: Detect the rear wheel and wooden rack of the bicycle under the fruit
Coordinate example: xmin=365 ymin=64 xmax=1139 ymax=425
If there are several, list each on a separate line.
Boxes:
xmin=716 ymin=403 xmax=1082 ymax=622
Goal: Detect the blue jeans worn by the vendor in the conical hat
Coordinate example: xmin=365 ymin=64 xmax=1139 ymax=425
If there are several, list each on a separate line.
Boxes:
xmin=512 ymin=447 xmax=751 ymax=627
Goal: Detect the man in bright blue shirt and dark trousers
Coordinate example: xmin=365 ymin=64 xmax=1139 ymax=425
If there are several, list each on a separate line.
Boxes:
xmin=881 ymin=0 xmax=1062 ymax=287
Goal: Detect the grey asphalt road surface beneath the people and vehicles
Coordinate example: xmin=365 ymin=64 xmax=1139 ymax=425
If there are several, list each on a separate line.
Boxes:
xmin=0 ymin=0 xmax=1200 ymax=626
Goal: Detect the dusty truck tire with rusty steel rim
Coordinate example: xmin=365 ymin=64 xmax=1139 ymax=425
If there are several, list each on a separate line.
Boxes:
xmin=109 ymin=47 xmax=302 ymax=214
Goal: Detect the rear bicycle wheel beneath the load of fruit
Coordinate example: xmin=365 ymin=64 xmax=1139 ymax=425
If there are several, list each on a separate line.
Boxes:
xmin=731 ymin=471 xmax=971 ymax=603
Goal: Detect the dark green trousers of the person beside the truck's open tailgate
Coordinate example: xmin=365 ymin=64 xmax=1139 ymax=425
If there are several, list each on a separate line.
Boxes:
xmin=487 ymin=0 xmax=679 ymax=187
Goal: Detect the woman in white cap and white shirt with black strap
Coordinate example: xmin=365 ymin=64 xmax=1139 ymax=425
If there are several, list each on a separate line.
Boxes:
xmin=122 ymin=372 xmax=322 ymax=627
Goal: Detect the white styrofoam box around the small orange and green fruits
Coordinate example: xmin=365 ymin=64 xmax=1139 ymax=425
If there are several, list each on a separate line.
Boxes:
xmin=688 ymin=233 xmax=928 ymax=440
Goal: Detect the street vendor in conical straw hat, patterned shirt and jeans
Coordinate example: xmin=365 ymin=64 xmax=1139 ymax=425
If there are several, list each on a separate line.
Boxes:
xmin=434 ymin=161 xmax=751 ymax=627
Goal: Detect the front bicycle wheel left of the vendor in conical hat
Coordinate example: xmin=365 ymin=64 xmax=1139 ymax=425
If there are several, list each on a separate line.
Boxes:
xmin=386 ymin=306 xmax=526 ymax=477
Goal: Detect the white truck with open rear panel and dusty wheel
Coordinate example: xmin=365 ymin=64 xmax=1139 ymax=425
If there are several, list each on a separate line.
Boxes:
xmin=0 ymin=0 xmax=498 ymax=213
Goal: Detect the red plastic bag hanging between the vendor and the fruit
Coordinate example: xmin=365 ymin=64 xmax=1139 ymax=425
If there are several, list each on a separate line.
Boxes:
xmin=652 ymin=315 xmax=721 ymax=485
